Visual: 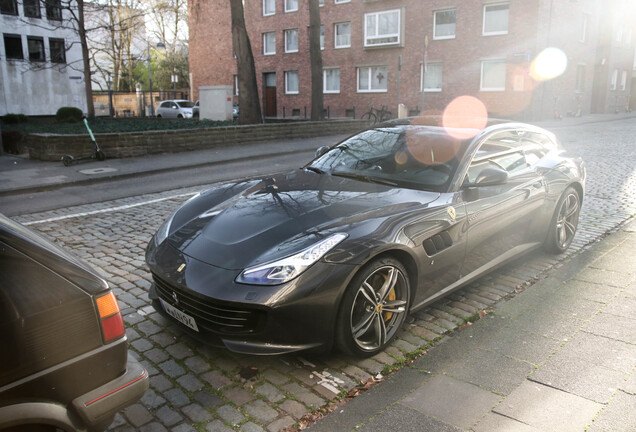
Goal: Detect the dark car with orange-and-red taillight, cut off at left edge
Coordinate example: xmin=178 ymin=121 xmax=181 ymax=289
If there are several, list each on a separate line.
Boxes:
xmin=0 ymin=215 xmax=149 ymax=432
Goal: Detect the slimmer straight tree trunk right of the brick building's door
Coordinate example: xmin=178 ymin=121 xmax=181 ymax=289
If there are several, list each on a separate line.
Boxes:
xmin=309 ymin=0 xmax=324 ymax=121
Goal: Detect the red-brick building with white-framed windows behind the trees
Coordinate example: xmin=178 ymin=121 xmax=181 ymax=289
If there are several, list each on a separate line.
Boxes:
xmin=190 ymin=0 xmax=634 ymax=120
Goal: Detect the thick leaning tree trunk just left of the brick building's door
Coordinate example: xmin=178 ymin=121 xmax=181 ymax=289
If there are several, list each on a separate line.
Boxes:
xmin=230 ymin=0 xmax=260 ymax=124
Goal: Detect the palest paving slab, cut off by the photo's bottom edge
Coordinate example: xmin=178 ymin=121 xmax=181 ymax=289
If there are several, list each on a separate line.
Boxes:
xmin=493 ymin=381 xmax=603 ymax=432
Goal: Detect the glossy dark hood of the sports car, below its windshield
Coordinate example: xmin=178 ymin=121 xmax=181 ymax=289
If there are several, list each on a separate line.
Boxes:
xmin=168 ymin=170 xmax=439 ymax=270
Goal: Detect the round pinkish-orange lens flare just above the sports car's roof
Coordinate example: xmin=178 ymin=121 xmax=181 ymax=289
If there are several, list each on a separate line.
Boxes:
xmin=442 ymin=96 xmax=488 ymax=139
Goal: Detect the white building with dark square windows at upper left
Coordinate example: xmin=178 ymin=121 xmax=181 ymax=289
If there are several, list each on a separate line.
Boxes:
xmin=0 ymin=0 xmax=87 ymax=116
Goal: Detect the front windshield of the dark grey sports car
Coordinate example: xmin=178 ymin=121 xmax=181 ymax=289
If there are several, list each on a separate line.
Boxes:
xmin=306 ymin=126 xmax=463 ymax=192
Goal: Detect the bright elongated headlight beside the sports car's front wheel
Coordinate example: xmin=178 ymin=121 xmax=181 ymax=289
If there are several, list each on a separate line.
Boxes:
xmin=236 ymin=233 xmax=347 ymax=285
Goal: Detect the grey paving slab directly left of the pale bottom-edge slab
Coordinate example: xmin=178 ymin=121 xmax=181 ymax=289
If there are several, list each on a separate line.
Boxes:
xmin=401 ymin=375 xmax=501 ymax=429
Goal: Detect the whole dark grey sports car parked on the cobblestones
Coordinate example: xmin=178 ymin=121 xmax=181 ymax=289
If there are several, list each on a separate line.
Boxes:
xmin=146 ymin=120 xmax=585 ymax=356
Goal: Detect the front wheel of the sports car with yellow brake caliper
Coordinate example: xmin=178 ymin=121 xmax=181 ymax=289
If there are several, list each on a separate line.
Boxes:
xmin=336 ymin=258 xmax=411 ymax=357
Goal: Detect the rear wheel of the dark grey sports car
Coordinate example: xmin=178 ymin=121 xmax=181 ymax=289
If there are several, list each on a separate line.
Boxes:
xmin=543 ymin=187 xmax=581 ymax=254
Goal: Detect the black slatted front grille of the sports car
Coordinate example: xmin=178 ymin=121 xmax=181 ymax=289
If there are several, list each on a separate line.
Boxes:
xmin=153 ymin=275 xmax=265 ymax=334
